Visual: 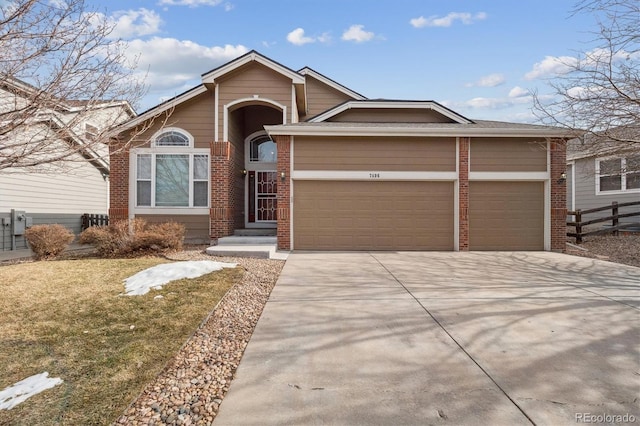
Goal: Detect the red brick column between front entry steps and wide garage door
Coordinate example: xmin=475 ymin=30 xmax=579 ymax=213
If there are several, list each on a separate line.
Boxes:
xmin=274 ymin=136 xmax=291 ymax=250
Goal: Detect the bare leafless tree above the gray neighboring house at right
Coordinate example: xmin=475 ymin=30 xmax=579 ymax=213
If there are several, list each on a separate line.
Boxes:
xmin=534 ymin=0 xmax=640 ymax=159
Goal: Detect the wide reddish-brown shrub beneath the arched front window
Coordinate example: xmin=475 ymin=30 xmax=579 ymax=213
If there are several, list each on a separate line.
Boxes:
xmin=78 ymin=219 xmax=185 ymax=257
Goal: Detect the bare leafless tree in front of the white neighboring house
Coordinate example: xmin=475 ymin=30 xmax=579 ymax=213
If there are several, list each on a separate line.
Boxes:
xmin=0 ymin=0 xmax=159 ymax=173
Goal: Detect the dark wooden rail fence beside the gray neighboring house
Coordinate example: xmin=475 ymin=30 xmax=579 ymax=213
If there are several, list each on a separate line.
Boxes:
xmin=567 ymin=201 xmax=640 ymax=244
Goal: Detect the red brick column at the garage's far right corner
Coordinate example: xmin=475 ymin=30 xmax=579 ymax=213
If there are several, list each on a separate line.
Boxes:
xmin=549 ymin=139 xmax=567 ymax=253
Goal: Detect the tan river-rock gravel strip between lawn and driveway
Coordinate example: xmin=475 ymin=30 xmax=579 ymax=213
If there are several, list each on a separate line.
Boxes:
xmin=116 ymin=248 xmax=284 ymax=426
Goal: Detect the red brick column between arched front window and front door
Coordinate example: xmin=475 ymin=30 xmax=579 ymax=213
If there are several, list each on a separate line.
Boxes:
xmin=209 ymin=141 xmax=234 ymax=240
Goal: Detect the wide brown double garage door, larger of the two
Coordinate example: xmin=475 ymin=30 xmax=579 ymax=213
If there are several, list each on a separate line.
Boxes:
xmin=293 ymin=181 xmax=453 ymax=250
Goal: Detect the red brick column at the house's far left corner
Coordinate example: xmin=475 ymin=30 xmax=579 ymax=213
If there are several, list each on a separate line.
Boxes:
xmin=109 ymin=140 xmax=129 ymax=223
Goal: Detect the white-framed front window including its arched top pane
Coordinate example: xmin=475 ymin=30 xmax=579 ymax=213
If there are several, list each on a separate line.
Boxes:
xmin=136 ymin=128 xmax=209 ymax=208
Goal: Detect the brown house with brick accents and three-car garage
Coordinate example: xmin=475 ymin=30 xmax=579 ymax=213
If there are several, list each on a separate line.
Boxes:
xmin=109 ymin=51 xmax=567 ymax=251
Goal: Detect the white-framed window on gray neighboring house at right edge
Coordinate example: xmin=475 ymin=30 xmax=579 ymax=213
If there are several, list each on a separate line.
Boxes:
xmin=596 ymin=155 xmax=640 ymax=194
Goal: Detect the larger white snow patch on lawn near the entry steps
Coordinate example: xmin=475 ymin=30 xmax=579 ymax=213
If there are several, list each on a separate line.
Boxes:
xmin=124 ymin=260 xmax=236 ymax=296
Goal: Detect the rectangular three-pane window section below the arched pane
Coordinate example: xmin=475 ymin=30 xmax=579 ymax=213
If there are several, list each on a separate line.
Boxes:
xmin=136 ymin=154 xmax=209 ymax=207
